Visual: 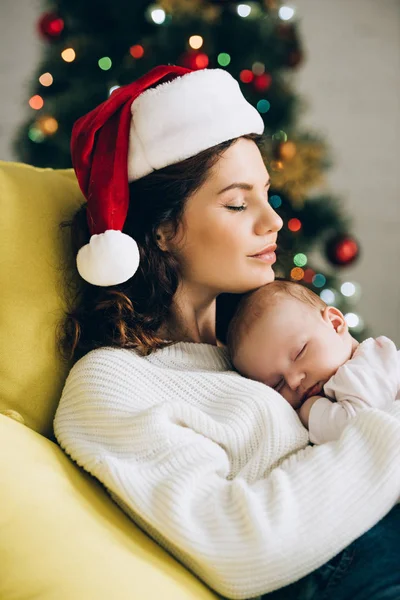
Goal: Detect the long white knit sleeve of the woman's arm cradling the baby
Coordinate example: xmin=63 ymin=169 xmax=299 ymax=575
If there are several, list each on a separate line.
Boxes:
xmin=54 ymin=354 xmax=400 ymax=599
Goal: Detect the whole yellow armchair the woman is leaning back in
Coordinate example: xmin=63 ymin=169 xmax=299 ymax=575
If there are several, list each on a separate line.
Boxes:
xmin=0 ymin=161 xmax=219 ymax=600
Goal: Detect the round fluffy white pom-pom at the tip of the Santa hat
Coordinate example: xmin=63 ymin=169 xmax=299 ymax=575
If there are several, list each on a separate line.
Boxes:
xmin=76 ymin=229 xmax=140 ymax=287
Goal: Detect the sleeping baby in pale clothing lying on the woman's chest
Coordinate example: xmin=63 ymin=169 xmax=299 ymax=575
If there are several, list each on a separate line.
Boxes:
xmin=227 ymin=279 xmax=400 ymax=444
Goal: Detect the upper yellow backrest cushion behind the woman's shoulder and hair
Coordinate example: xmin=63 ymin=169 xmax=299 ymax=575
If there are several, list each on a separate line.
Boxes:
xmin=0 ymin=161 xmax=84 ymax=437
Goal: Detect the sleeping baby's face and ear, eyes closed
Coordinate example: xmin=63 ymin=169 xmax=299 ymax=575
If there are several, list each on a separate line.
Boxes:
xmin=234 ymin=298 xmax=353 ymax=409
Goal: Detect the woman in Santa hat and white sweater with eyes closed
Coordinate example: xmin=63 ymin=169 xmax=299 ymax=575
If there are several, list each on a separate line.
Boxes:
xmin=54 ymin=67 xmax=400 ymax=600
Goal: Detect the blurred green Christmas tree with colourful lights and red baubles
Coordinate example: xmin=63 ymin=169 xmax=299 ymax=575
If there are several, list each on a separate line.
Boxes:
xmin=15 ymin=0 xmax=366 ymax=340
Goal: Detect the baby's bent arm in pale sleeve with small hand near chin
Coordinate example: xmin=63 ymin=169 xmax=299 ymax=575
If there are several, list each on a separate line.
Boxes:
xmin=299 ymin=336 xmax=399 ymax=444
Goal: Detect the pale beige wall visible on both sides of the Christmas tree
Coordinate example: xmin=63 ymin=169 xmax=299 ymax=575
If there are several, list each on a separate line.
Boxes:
xmin=0 ymin=0 xmax=400 ymax=347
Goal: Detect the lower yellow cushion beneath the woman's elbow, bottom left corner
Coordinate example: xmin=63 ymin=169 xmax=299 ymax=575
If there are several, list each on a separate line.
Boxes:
xmin=0 ymin=415 xmax=218 ymax=600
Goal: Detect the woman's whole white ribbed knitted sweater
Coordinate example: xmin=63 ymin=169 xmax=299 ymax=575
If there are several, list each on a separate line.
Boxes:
xmin=54 ymin=342 xmax=400 ymax=599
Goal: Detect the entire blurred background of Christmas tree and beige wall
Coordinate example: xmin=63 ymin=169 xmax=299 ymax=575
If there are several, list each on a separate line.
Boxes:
xmin=0 ymin=0 xmax=400 ymax=347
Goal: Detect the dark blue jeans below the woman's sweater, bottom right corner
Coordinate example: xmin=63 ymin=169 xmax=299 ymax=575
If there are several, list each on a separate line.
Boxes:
xmin=261 ymin=504 xmax=400 ymax=600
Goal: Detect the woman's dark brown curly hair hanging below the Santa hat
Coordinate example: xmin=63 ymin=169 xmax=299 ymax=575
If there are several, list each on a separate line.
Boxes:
xmin=57 ymin=134 xmax=266 ymax=361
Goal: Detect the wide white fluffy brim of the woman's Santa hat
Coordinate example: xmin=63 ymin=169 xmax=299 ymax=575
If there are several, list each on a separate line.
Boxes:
xmin=128 ymin=69 xmax=264 ymax=181
